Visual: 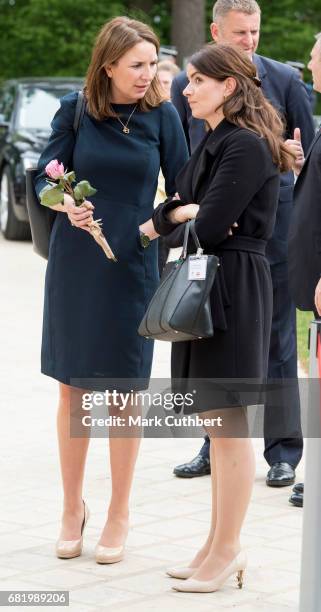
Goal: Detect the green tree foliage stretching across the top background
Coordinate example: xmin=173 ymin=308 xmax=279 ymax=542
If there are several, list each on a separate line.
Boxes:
xmin=0 ymin=0 xmax=321 ymax=101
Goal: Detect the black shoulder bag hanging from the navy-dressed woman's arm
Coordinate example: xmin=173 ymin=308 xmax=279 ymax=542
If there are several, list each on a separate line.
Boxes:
xmin=26 ymin=91 xmax=86 ymax=259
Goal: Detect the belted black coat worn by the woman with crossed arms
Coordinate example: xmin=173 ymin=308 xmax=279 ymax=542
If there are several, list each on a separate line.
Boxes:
xmin=153 ymin=119 xmax=280 ymax=394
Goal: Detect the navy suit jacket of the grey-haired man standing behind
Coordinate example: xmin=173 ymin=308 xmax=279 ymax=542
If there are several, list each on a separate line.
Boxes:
xmin=172 ymin=55 xmax=314 ymax=264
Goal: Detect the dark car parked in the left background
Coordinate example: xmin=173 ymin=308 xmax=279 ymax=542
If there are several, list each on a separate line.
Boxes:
xmin=0 ymin=77 xmax=83 ymax=240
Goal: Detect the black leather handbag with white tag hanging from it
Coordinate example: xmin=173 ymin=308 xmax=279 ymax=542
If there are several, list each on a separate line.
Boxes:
xmin=138 ymin=220 xmax=219 ymax=342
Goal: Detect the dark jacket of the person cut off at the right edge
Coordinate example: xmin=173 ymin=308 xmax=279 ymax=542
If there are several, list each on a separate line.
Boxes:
xmin=288 ymin=130 xmax=321 ymax=310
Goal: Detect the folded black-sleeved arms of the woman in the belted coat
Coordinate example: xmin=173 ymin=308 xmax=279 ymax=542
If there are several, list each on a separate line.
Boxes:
xmin=153 ymin=131 xmax=271 ymax=249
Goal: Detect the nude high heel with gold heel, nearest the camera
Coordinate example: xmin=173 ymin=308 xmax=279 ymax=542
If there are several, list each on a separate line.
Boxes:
xmin=172 ymin=551 xmax=247 ymax=593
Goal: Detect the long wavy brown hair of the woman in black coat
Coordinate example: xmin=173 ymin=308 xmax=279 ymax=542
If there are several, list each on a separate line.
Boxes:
xmin=189 ymin=43 xmax=294 ymax=172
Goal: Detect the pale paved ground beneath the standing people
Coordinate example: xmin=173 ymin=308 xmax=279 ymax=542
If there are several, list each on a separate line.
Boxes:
xmin=0 ymin=239 xmax=303 ymax=612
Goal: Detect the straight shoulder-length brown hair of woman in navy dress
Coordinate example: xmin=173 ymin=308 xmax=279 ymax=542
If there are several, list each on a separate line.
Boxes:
xmin=84 ymin=17 xmax=164 ymax=119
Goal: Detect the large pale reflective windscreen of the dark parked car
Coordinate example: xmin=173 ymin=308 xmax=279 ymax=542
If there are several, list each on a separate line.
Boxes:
xmin=17 ymin=86 xmax=77 ymax=130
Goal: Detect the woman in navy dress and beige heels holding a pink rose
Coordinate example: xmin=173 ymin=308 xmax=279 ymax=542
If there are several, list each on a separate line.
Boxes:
xmin=36 ymin=17 xmax=187 ymax=563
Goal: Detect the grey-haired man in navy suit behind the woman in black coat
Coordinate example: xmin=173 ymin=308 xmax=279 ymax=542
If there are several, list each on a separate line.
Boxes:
xmin=172 ymin=0 xmax=314 ymax=487
